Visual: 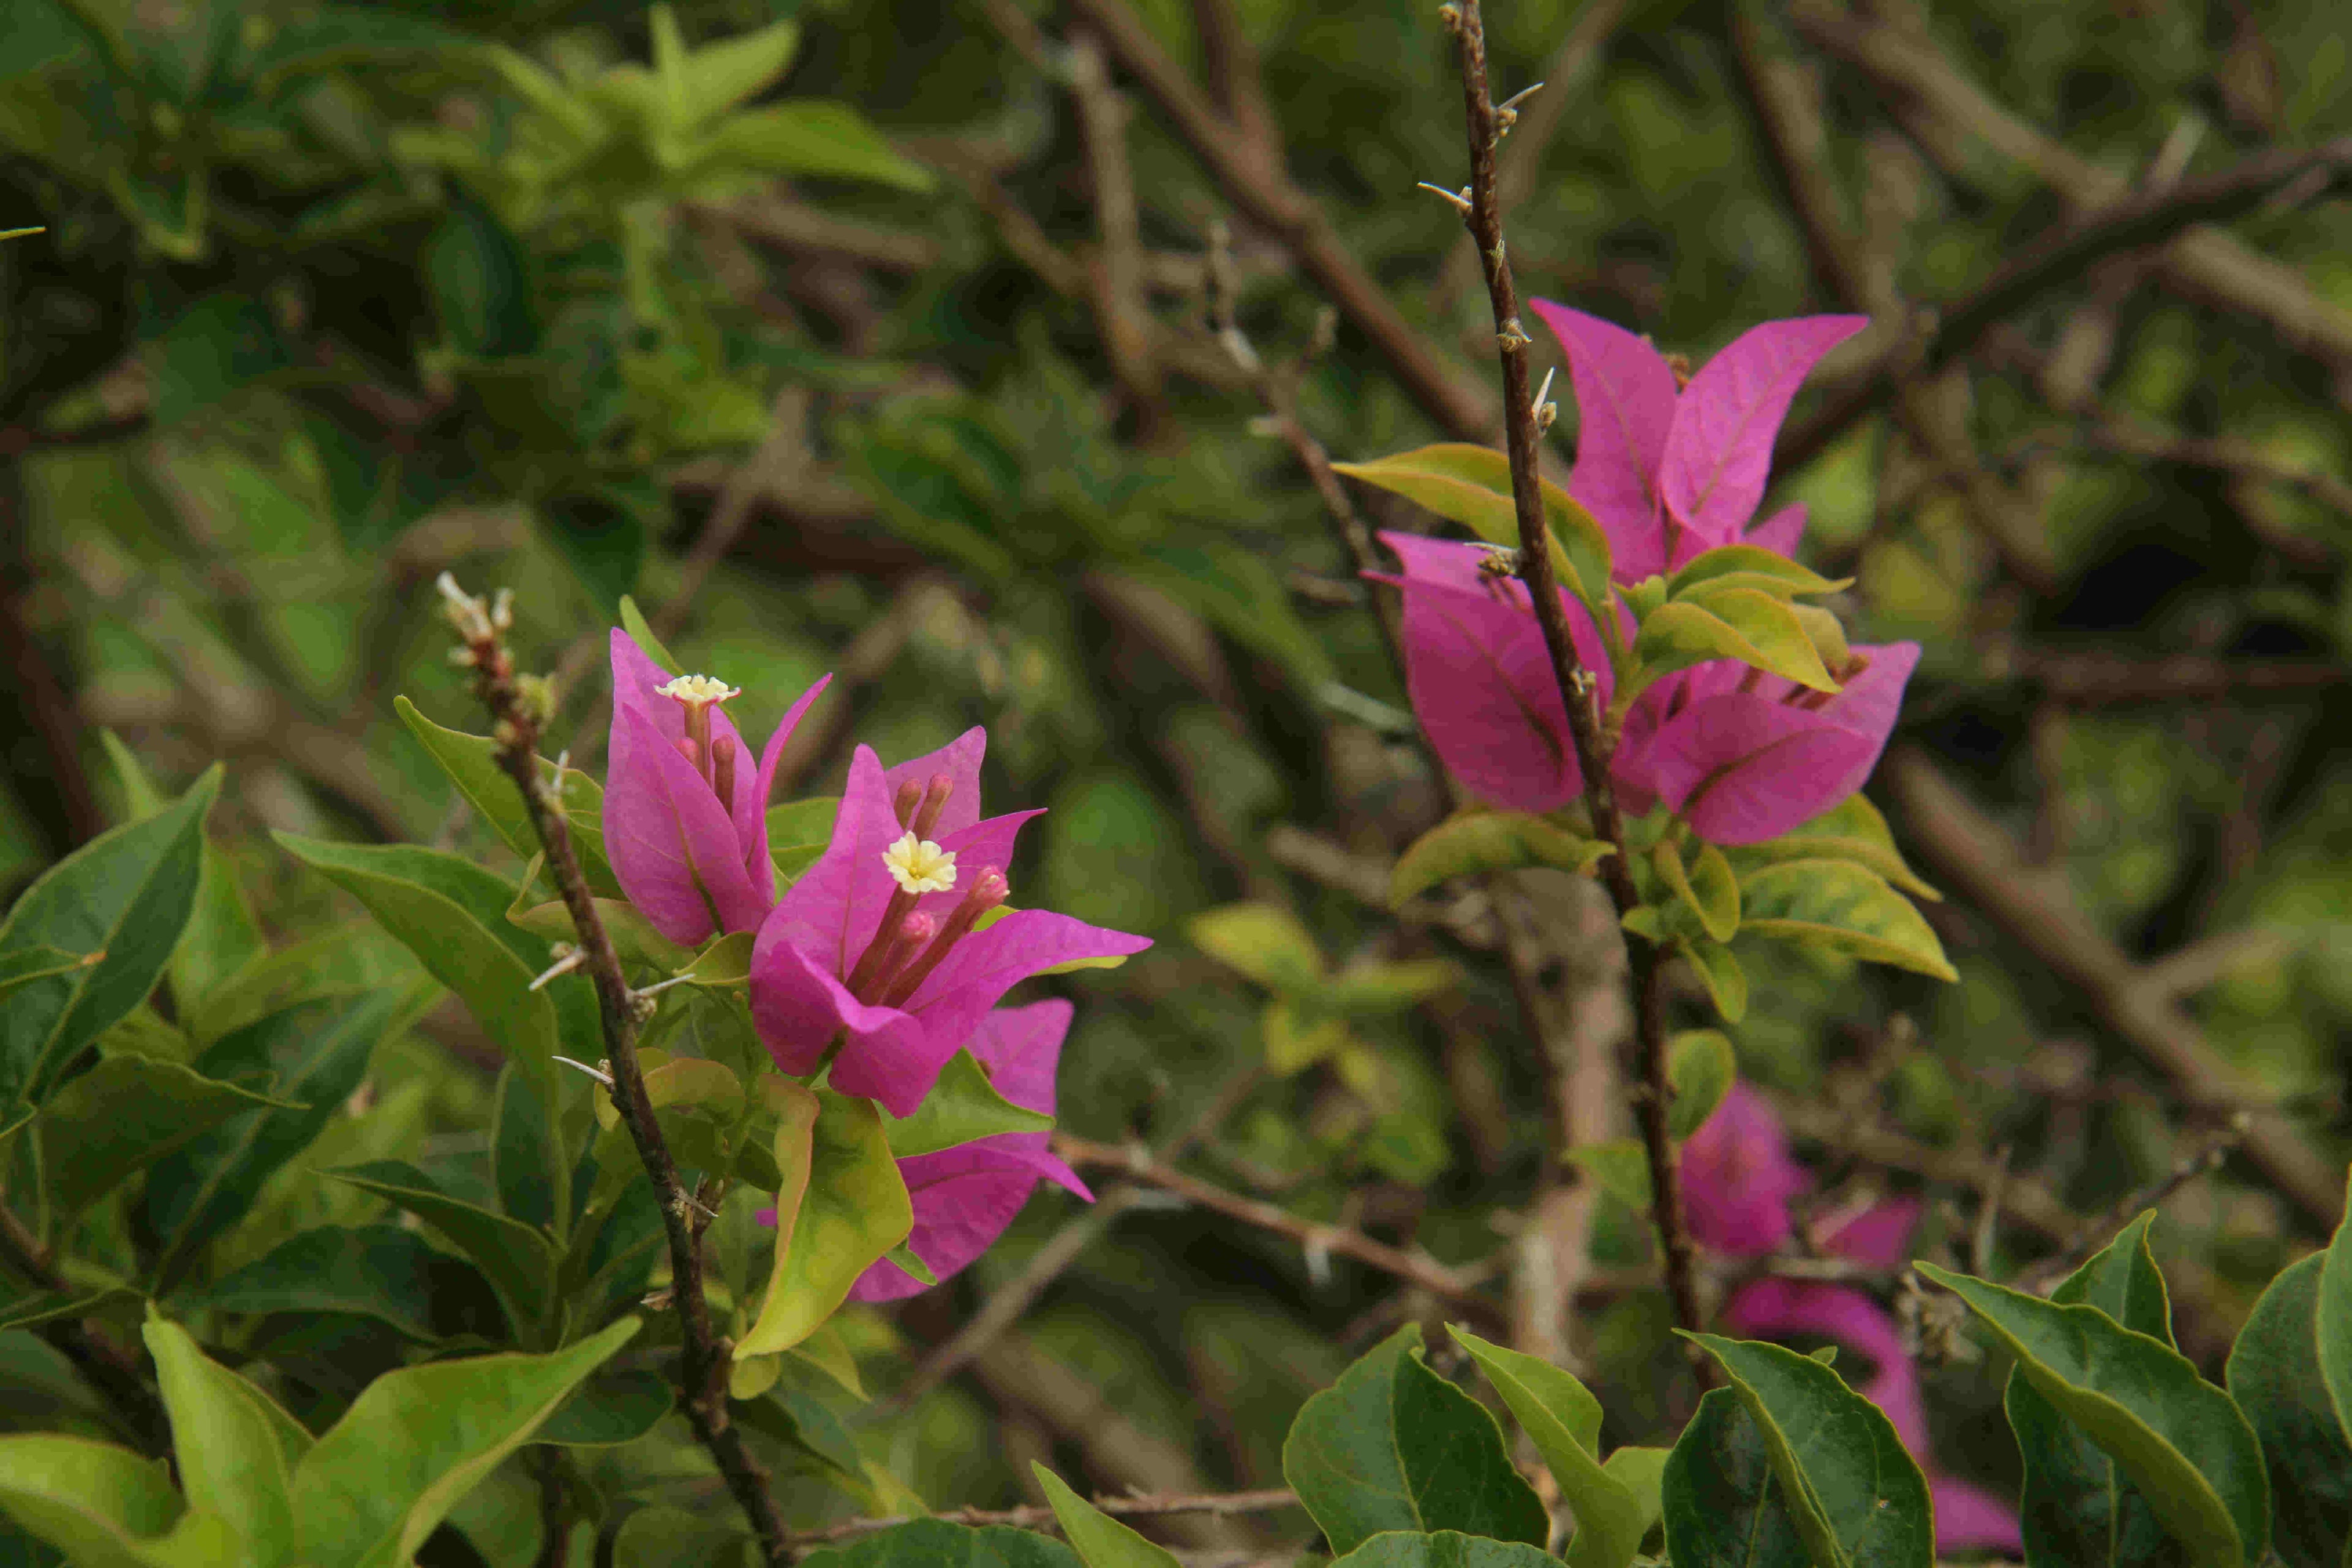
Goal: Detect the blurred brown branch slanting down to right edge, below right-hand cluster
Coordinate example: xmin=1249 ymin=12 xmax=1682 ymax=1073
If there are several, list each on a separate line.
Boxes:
xmin=1882 ymin=748 xmax=2343 ymax=1227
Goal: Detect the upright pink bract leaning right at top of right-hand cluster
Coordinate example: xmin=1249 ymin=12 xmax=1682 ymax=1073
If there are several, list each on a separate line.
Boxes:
xmin=1658 ymin=315 xmax=1870 ymax=548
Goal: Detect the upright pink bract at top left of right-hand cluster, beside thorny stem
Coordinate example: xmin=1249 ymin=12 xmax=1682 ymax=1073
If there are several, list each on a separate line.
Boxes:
xmin=1529 ymin=298 xmax=1675 ymax=583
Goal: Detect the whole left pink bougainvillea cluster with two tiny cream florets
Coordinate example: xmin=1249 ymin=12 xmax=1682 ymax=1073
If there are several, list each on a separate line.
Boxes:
xmin=588 ymin=630 xmax=1150 ymax=1300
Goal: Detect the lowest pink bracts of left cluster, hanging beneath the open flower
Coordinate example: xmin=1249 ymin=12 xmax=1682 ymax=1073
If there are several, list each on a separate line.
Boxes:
xmin=849 ymin=1001 xmax=1094 ymax=1302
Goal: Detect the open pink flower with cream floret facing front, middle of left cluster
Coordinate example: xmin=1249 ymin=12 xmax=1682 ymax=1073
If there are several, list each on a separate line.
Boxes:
xmin=750 ymin=729 xmax=1150 ymax=1117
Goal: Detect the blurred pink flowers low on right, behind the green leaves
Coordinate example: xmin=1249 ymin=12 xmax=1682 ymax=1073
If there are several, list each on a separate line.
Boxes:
xmin=1682 ymin=1084 xmax=2025 ymax=1554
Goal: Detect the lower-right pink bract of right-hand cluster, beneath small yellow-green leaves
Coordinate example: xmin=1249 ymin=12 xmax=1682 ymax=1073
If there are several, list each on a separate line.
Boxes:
xmin=1611 ymin=642 xmax=1919 ymax=844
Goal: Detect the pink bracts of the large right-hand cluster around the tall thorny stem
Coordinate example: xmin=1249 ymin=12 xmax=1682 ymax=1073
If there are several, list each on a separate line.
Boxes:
xmin=1369 ymin=298 xmax=1919 ymax=844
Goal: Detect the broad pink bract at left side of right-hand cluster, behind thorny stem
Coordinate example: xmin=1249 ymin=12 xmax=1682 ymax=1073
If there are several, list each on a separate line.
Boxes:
xmin=1364 ymin=533 xmax=1613 ymax=811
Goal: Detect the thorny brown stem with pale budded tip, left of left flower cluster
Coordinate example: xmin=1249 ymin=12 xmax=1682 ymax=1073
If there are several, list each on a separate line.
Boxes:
xmin=440 ymin=573 xmax=793 ymax=1568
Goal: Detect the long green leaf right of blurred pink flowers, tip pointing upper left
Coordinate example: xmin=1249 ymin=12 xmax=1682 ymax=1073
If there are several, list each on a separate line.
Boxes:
xmin=1915 ymin=1262 xmax=2270 ymax=1568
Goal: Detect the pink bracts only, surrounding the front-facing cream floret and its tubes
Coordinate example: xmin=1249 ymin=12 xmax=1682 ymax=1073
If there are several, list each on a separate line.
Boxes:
xmin=750 ymin=747 xmax=1150 ymax=1114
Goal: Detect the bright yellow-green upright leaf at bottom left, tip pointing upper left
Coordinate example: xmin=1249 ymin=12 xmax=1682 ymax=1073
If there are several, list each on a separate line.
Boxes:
xmin=143 ymin=1307 xmax=311 ymax=1568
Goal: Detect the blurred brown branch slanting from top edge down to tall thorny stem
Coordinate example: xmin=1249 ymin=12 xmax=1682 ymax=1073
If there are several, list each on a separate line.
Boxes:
xmin=1070 ymin=0 xmax=1493 ymax=440
